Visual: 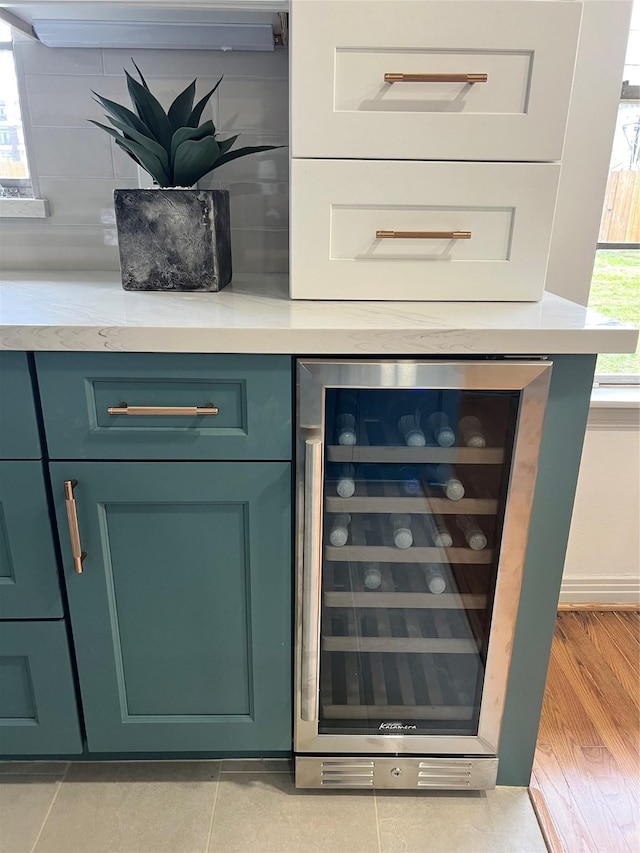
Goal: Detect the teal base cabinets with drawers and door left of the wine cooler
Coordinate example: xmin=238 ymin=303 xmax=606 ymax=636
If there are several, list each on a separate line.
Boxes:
xmin=0 ymin=352 xmax=292 ymax=756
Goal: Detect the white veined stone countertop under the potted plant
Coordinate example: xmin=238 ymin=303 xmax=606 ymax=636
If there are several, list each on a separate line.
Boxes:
xmin=0 ymin=272 xmax=638 ymax=356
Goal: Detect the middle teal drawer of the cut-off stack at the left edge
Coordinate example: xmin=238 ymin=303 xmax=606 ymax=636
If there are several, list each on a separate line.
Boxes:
xmin=0 ymin=462 xmax=63 ymax=619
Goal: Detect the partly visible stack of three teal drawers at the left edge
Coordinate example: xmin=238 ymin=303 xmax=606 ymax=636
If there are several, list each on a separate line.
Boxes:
xmin=0 ymin=352 xmax=82 ymax=757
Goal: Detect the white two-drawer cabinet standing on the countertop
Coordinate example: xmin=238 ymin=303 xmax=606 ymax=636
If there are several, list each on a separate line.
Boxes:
xmin=290 ymin=0 xmax=583 ymax=302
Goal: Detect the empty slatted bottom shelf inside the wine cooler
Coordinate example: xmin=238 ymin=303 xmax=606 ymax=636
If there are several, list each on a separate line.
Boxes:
xmin=320 ymin=652 xmax=479 ymax=721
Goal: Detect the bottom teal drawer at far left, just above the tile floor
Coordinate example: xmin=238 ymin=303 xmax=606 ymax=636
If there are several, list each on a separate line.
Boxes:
xmin=0 ymin=621 xmax=82 ymax=757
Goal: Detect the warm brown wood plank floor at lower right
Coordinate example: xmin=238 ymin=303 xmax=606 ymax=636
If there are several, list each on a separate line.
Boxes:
xmin=531 ymin=611 xmax=640 ymax=853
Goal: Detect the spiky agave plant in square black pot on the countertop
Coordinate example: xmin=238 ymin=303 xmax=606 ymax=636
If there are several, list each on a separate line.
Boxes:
xmin=92 ymin=62 xmax=277 ymax=291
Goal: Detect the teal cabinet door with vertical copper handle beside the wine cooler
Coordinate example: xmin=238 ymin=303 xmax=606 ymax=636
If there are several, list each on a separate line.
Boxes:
xmin=50 ymin=462 xmax=291 ymax=754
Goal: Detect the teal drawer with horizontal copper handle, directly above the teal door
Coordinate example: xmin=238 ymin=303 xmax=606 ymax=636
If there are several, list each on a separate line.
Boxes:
xmin=36 ymin=352 xmax=291 ymax=460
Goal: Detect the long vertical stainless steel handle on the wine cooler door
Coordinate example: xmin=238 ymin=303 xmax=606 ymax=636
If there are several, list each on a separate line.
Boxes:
xmin=300 ymin=438 xmax=323 ymax=722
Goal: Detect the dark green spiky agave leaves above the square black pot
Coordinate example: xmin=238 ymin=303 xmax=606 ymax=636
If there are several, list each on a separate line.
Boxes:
xmin=90 ymin=60 xmax=281 ymax=187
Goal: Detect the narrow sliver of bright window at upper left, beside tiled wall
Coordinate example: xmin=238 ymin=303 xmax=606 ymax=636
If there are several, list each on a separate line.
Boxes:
xmin=0 ymin=22 xmax=33 ymax=197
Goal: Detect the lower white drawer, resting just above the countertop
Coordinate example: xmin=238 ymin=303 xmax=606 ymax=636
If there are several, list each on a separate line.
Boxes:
xmin=290 ymin=160 xmax=560 ymax=302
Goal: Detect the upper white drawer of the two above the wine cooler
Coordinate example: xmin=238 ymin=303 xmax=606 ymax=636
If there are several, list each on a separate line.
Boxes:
xmin=291 ymin=0 xmax=582 ymax=161
